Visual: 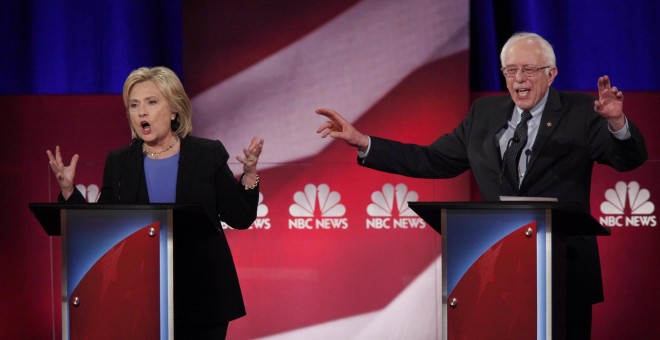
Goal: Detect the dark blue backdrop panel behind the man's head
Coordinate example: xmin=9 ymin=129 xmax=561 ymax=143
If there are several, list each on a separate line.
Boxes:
xmin=470 ymin=0 xmax=660 ymax=91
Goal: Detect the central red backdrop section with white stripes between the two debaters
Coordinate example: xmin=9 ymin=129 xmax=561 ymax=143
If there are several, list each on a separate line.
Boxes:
xmin=188 ymin=0 xmax=470 ymax=339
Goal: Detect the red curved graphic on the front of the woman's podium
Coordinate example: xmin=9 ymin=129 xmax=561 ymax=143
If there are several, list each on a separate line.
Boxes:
xmin=68 ymin=222 xmax=160 ymax=339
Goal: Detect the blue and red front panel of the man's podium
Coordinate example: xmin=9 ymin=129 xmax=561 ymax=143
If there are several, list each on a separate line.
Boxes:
xmin=441 ymin=209 xmax=551 ymax=339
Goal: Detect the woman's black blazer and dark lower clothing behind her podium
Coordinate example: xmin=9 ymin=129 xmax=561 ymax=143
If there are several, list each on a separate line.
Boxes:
xmin=68 ymin=136 xmax=259 ymax=327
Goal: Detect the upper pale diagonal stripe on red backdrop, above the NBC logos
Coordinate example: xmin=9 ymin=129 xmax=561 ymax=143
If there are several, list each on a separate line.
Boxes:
xmin=193 ymin=0 xmax=469 ymax=169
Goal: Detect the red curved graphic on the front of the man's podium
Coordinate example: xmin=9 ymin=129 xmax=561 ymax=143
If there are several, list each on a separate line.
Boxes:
xmin=447 ymin=222 xmax=536 ymax=339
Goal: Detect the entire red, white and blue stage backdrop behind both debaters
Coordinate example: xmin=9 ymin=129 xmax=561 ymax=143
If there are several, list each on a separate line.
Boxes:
xmin=0 ymin=0 xmax=660 ymax=339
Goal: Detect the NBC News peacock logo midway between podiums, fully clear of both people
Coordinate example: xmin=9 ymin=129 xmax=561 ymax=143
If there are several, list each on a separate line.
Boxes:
xmin=289 ymin=184 xmax=348 ymax=230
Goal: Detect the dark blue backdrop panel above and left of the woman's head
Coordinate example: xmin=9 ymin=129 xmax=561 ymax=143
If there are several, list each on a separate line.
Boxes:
xmin=0 ymin=0 xmax=182 ymax=94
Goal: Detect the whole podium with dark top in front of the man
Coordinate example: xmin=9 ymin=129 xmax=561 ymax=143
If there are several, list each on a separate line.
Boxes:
xmin=408 ymin=202 xmax=610 ymax=340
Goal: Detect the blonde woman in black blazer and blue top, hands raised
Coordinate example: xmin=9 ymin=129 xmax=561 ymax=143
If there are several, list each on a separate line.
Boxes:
xmin=47 ymin=67 xmax=263 ymax=339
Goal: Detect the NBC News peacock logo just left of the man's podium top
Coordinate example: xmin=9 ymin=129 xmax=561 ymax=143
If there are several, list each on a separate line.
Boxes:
xmin=366 ymin=183 xmax=426 ymax=229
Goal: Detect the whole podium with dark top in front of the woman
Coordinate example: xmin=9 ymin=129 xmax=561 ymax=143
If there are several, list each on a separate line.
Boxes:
xmin=29 ymin=203 xmax=215 ymax=339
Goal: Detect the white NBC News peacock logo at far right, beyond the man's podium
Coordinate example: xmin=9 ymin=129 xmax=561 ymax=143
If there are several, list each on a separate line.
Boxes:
xmin=600 ymin=181 xmax=656 ymax=227
